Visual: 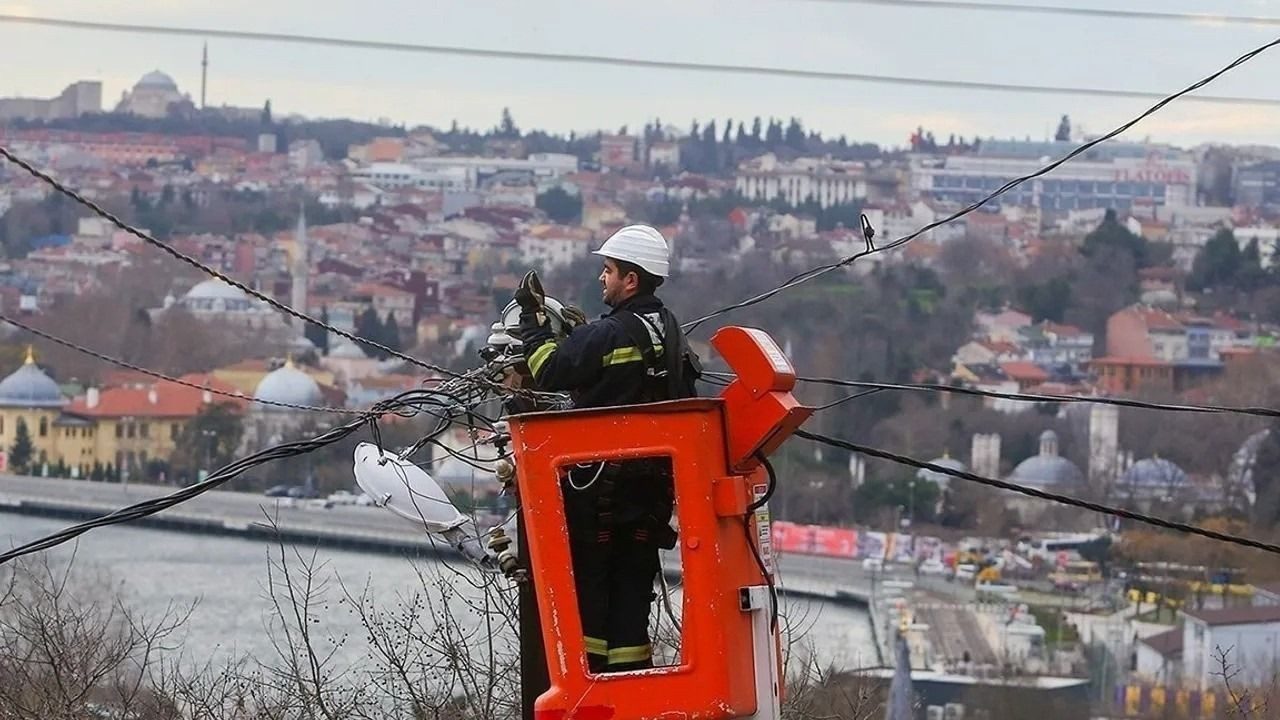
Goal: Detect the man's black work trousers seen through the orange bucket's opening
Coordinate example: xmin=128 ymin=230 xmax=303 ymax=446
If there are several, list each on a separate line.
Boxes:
xmin=562 ymin=459 xmax=675 ymax=673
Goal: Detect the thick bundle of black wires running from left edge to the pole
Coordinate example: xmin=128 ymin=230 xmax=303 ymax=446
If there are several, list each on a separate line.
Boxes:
xmin=0 ymin=366 xmax=519 ymax=565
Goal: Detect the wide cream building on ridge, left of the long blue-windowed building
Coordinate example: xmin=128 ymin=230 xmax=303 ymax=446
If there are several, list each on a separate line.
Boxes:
xmin=733 ymin=152 xmax=867 ymax=208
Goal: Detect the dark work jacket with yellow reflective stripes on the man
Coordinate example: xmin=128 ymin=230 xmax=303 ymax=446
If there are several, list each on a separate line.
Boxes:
xmin=520 ymin=289 xmax=680 ymax=407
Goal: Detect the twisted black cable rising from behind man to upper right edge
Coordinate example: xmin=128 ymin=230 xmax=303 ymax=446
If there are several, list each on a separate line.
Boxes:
xmin=681 ymin=38 xmax=1280 ymax=333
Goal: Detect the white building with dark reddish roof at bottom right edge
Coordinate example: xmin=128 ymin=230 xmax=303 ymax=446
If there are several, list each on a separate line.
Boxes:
xmin=1181 ymin=605 xmax=1280 ymax=689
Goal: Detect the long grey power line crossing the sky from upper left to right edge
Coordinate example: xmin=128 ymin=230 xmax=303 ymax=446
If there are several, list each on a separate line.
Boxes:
xmin=0 ymin=14 xmax=1280 ymax=105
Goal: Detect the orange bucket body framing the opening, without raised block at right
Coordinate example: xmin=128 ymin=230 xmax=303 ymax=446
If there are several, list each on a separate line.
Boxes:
xmin=509 ymin=398 xmax=765 ymax=720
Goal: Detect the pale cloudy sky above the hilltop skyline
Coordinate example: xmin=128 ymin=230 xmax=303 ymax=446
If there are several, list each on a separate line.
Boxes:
xmin=0 ymin=0 xmax=1280 ymax=146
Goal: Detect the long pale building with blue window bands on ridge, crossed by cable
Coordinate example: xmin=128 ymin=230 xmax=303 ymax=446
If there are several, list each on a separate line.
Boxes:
xmin=910 ymin=140 xmax=1196 ymax=213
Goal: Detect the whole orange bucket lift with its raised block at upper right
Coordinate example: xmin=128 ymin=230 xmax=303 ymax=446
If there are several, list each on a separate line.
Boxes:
xmin=508 ymin=327 xmax=812 ymax=720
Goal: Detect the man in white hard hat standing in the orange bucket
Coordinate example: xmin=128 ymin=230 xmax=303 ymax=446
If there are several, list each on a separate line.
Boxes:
xmin=516 ymin=225 xmax=699 ymax=673
